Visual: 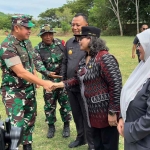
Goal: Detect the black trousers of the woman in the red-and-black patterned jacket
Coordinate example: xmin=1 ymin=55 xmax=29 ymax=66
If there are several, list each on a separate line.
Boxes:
xmin=92 ymin=126 xmax=119 ymax=150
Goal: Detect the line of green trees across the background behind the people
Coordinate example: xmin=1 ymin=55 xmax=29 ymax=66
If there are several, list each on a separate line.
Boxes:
xmin=0 ymin=0 xmax=150 ymax=36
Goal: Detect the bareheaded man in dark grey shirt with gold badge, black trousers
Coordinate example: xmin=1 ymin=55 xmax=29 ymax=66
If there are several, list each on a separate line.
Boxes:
xmin=62 ymin=13 xmax=94 ymax=150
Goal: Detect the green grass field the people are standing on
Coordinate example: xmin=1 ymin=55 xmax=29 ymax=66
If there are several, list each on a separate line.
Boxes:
xmin=0 ymin=36 xmax=138 ymax=150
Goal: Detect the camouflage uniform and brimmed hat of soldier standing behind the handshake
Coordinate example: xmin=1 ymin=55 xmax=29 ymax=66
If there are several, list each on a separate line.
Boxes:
xmin=34 ymin=24 xmax=71 ymax=124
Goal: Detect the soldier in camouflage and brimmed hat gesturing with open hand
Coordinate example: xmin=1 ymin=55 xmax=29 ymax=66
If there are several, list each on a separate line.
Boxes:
xmin=34 ymin=24 xmax=71 ymax=138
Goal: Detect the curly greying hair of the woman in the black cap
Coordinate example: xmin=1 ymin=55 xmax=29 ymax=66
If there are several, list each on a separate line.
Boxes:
xmin=89 ymin=36 xmax=109 ymax=55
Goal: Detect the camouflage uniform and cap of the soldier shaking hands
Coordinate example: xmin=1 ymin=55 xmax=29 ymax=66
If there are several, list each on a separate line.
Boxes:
xmin=0 ymin=16 xmax=37 ymax=145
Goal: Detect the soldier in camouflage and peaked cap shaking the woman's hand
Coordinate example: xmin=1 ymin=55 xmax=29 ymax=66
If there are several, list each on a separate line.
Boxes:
xmin=0 ymin=15 xmax=51 ymax=150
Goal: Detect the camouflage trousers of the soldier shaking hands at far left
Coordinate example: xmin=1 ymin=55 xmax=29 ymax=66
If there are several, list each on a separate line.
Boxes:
xmin=3 ymin=97 xmax=37 ymax=145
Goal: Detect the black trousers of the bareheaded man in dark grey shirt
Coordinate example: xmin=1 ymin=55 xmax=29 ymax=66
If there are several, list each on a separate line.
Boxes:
xmin=67 ymin=90 xmax=94 ymax=148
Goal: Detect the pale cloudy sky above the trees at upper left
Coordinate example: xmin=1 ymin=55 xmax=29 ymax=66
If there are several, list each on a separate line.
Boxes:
xmin=0 ymin=0 xmax=67 ymax=19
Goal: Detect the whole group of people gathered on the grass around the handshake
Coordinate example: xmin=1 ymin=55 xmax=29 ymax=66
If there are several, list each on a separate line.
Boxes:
xmin=0 ymin=13 xmax=150 ymax=150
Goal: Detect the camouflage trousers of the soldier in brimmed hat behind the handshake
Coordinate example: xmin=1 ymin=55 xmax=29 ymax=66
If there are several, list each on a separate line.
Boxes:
xmin=43 ymin=89 xmax=71 ymax=124
